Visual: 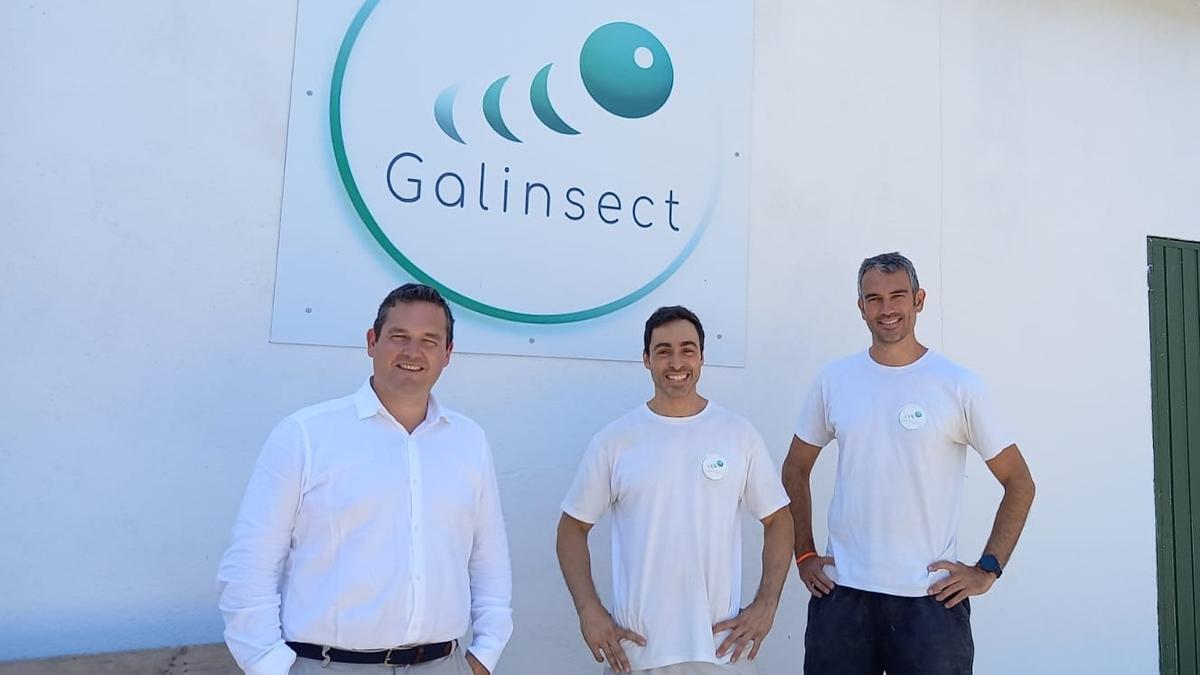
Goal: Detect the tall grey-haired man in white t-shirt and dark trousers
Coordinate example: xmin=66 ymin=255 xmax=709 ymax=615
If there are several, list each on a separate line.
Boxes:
xmin=784 ymin=253 xmax=1034 ymax=675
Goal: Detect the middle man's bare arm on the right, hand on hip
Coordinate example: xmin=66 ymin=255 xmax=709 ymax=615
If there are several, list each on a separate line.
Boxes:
xmin=713 ymin=507 xmax=793 ymax=662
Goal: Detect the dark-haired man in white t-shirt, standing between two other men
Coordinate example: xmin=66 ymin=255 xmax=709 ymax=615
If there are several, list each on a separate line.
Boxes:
xmin=558 ymin=306 xmax=792 ymax=675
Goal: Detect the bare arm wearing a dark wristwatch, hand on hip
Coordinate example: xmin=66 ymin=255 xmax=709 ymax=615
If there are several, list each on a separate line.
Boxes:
xmin=929 ymin=446 xmax=1037 ymax=608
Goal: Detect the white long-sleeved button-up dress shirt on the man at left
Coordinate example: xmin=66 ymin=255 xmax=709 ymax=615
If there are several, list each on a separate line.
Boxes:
xmin=217 ymin=380 xmax=512 ymax=675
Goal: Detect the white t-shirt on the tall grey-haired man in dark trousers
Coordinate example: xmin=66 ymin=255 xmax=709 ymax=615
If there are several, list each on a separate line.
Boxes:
xmin=796 ymin=351 xmax=1013 ymax=597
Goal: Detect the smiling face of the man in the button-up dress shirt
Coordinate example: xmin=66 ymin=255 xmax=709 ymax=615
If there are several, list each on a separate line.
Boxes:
xmin=367 ymin=301 xmax=452 ymax=394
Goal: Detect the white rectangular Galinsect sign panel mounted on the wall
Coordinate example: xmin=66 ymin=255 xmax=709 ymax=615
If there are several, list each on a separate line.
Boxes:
xmin=271 ymin=0 xmax=752 ymax=365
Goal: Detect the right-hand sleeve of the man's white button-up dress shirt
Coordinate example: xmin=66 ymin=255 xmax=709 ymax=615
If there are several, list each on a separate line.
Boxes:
xmin=467 ymin=432 xmax=512 ymax=673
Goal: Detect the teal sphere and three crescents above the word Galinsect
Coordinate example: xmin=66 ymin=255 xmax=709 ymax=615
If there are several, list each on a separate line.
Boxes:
xmin=433 ymin=22 xmax=674 ymax=145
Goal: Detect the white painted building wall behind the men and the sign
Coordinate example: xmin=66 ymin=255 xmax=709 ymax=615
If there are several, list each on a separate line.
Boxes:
xmin=0 ymin=0 xmax=1200 ymax=675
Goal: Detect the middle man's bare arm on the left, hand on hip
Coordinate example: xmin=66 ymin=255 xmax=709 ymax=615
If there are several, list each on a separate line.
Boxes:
xmin=557 ymin=513 xmax=646 ymax=673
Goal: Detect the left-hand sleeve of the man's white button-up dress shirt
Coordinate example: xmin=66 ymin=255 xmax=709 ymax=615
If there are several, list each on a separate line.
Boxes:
xmin=217 ymin=418 xmax=306 ymax=675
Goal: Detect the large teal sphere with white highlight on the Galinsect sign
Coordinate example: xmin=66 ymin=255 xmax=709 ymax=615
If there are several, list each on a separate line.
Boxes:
xmin=580 ymin=22 xmax=674 ymax=119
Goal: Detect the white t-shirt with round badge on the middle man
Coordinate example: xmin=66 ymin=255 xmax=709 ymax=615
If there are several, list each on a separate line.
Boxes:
xmin=563 ymin=402 xmax=788 ymax=670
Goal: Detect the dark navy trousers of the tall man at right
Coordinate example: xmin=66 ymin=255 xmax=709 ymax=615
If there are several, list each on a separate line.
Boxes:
xmin=804 ymin=586 xmax=974 ymax=675
